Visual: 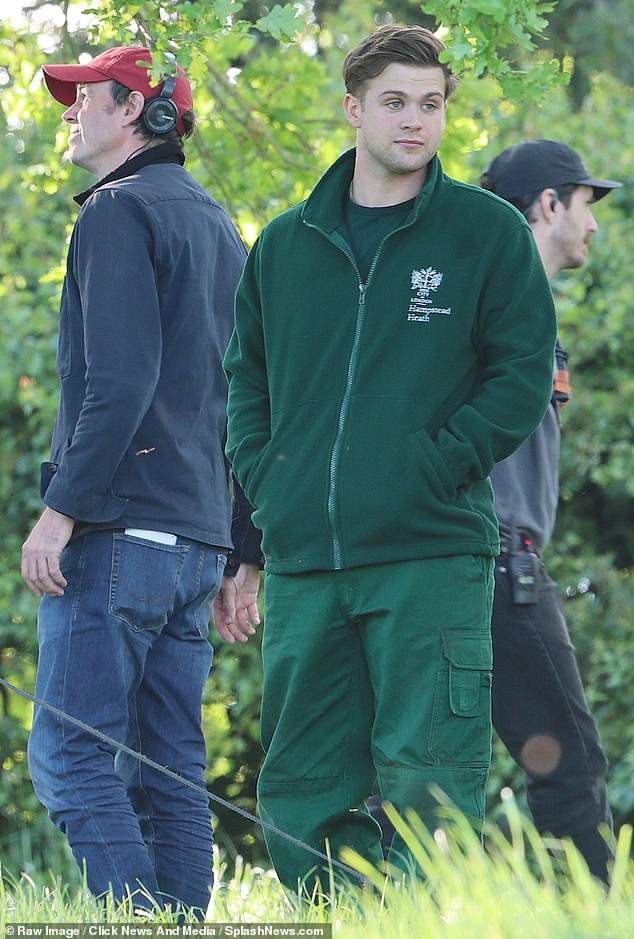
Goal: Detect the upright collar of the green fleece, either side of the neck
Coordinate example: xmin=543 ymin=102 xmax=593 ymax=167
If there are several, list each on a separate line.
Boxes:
xmin=302 ymin=147 xmax=443 ymax=234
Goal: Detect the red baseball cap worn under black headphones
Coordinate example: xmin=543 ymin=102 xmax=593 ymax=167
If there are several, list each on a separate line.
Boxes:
xmin=42 ymin=46 xmax=194 ymax=136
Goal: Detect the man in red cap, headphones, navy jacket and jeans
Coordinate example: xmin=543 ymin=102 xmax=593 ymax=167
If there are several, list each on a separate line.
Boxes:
xmin=22 ymin=47 xmax=259 ymax=916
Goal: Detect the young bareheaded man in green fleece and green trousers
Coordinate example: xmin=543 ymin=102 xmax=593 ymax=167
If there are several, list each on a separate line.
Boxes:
xmin=225 ymin=26 xmax=556 ymax=890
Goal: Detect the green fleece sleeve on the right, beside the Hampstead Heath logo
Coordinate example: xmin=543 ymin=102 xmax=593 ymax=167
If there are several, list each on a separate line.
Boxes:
xmin=435 ymin=219 xmax=557 ymax=487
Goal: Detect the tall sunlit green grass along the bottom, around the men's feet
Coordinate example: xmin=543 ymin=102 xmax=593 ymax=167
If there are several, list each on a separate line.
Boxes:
xmin=0 ymin=805 xmax=634 ymax=939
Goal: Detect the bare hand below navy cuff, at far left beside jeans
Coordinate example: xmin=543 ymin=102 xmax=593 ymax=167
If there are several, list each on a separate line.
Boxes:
xmin=22 ymin=505 xmax=75 ymax=597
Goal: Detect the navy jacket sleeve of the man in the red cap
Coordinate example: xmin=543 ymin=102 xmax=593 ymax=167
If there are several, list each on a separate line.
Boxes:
xmin=44 ymin=191 xmax=162 ymax=522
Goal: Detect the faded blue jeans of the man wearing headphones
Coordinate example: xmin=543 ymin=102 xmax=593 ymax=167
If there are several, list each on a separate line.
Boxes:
xmin=29 ymin=531 xmax=226 ymax=911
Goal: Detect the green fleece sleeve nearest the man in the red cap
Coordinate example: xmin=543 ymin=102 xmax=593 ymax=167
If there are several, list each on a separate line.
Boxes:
xmin=224 ymin=239 xmax=271 ymax=501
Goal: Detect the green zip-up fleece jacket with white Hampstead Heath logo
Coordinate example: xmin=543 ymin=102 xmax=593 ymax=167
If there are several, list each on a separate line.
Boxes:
xmin=225 ymin=151 xmax=556 ymax=573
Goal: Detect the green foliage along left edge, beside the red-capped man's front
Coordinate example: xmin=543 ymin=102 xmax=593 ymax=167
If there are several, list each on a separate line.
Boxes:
xmin=0 ymin=25 xmax=80 ymax=871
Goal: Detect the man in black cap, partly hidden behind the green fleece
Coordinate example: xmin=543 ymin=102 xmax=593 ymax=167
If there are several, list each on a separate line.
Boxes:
xmin=481 ymin=140 xmax=621 ymax=882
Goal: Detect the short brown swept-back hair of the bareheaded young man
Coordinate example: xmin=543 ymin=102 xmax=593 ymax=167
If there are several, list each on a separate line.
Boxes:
xmin=343 ymin=26 xmax=459 ymax=98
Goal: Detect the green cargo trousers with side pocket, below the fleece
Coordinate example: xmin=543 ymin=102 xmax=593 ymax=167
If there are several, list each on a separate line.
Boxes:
xmin=258 ymin=556 xmax=493 ymax=891
